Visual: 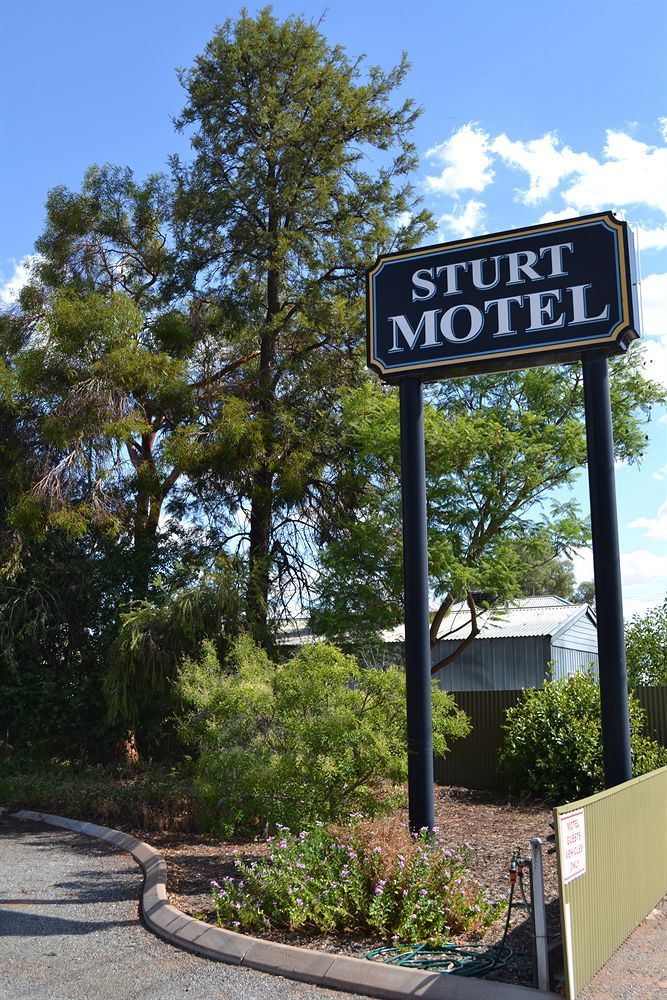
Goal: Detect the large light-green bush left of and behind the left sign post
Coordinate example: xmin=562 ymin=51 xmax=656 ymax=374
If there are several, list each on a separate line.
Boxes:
xmin=177 ymin=637 xmax=470 ymax=836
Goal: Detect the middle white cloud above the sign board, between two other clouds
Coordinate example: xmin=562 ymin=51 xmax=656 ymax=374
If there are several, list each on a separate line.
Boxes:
xmin=490 ymin=132 xmax=595 ymax=205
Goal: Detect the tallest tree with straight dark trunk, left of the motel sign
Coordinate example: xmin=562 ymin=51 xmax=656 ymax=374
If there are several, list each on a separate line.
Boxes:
xmin=173 ymin=8 xmax=430 ymax=643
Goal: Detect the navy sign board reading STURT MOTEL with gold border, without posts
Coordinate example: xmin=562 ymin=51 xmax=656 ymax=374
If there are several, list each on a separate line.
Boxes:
xmin=367 ymin=212 xmax=638 ymax=381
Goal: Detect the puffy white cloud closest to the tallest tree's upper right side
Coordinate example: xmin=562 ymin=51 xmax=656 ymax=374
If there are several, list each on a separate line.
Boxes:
xmin=426 ymin=122 xmax=493 ymax=194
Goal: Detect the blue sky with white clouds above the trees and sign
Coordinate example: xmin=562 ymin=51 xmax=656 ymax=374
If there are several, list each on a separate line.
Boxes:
xmin=0 ymin=0 xmax=667 ymax=618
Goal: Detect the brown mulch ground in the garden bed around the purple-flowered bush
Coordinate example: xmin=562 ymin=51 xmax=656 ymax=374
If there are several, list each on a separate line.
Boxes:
xmin=136 ymin=787 xmax=560 ymax=985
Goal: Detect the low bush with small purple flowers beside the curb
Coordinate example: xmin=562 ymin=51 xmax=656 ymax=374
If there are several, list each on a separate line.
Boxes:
xmin=212 ymin=826 xmax=500 ymax=945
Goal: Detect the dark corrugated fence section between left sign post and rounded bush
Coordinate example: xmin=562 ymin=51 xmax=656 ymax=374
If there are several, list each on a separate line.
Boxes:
xmin=435 ymin=691 xmax=521 ymax=790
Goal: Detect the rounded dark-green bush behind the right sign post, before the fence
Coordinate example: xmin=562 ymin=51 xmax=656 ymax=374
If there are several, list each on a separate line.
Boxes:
xmin=500 ymin=673 xmax=667 ymax=804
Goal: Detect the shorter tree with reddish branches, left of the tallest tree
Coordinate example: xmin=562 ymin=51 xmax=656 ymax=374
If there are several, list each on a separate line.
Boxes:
xmin=0 ymin=166 xmax=193 ymax=598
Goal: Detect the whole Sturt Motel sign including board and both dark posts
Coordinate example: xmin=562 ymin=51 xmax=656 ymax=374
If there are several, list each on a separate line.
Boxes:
xmin=366 ymin=212 xmax=639 ymax=830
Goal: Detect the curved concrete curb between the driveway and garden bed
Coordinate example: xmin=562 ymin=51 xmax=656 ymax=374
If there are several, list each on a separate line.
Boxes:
xmin=11 ymin=810 xmax=556 ymax=1000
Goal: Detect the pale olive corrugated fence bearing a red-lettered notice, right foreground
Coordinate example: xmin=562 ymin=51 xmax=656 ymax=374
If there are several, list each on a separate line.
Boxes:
xmin=555 ymin=767 xmax=667 ymax=1000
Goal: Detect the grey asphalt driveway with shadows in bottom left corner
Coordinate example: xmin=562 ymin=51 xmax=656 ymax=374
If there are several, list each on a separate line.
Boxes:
xmin=0 ymin=816 xmax=360 ymax=1000
